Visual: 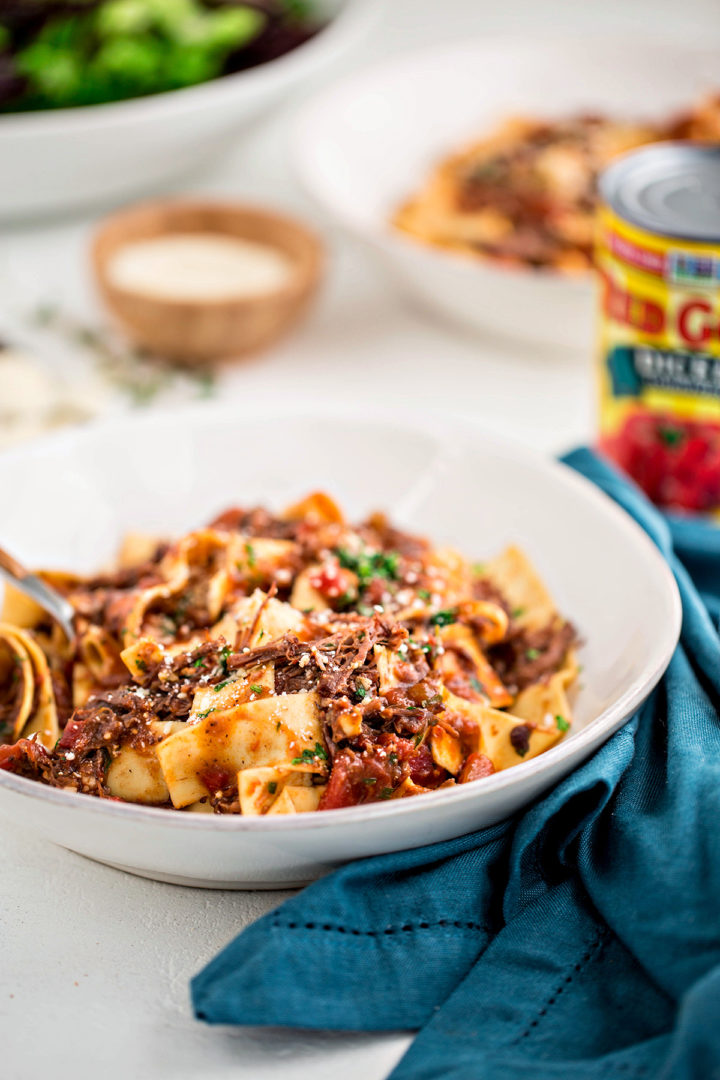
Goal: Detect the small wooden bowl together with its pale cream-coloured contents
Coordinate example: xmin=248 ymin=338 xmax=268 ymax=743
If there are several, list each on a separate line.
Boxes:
xmin=92 ymin=201 xmax=323 ymax=363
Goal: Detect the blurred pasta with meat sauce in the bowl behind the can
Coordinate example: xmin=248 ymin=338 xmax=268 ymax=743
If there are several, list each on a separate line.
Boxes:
xmin=393 ymin=93 xmax=720 ymax=273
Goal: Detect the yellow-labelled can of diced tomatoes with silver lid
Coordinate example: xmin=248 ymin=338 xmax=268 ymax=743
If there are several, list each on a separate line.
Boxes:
xmin=596 ymin=143 xmax=720 ymax=514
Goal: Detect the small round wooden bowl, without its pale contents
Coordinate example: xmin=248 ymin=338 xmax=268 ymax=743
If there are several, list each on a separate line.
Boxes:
xmin=91 ymin=200 xmax=324 ymax=364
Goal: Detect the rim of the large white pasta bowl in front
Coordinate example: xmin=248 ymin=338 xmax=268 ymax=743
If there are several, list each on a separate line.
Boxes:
xmin=0 ymin=402 xmax=682 ymax=833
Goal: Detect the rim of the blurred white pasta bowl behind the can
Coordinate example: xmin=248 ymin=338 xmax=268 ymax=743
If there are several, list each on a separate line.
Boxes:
xmin=289 ymin=30 xmax=716 ymax=285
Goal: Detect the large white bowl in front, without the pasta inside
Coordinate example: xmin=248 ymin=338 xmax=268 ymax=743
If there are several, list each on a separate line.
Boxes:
xmin=0 ymin=405 xmax=680 ymax=889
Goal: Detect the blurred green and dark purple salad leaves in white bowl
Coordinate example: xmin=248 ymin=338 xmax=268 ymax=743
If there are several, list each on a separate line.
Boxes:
xmin=0 ymin=0 xmax=315 ymax=111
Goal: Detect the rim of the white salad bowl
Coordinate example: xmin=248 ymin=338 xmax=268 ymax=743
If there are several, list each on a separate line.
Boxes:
xmin=0 ymin=0 xmax=382 ymax=135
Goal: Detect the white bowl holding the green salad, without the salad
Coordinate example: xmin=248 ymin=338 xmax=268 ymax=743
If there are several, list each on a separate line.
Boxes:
xmin=0 ymin=0 xmax=380 ymax=222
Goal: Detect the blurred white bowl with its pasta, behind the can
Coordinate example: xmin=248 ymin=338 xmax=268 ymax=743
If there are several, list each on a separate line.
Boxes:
xmin=294 ymin=37 xmax=720 ymax=348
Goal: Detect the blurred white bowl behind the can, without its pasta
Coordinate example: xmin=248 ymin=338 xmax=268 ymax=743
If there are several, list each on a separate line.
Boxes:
xmin=293 ymin=36 xmax=720 ymax=349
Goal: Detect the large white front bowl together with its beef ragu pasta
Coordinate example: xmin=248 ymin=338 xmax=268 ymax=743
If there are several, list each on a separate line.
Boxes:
xmin=0 ymin=406 xmax=680 ymax=888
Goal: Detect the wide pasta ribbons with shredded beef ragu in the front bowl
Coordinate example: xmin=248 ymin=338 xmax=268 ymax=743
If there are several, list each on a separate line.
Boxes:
xmin=0 ymin=495 xmax=576 ymax=814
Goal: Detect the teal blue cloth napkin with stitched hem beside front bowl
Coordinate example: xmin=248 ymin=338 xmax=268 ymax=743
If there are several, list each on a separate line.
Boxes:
xmin=192 ymin=449 xmax=720 ymax=1080
